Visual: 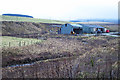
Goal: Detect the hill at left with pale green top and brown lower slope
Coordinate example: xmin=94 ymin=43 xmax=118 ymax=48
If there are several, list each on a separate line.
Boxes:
xmin=0 ymin=15 xmax=69 ymax=35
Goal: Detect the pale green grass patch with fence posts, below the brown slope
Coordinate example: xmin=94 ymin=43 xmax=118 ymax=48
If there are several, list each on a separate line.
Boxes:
xmin=0 ymin=36 xmax=42 ymax=47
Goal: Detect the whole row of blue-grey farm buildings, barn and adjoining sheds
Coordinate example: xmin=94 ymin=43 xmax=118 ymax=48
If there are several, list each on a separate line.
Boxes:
xmin=58 ymin=24 xmax=107 ymax=34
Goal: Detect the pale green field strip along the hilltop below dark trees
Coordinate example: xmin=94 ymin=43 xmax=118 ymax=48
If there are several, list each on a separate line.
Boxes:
xmin=0 ymin=15 xmax=71 ymax=24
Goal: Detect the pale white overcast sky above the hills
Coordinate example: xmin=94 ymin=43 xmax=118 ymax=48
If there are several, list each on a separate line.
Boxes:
xmin=0 ymin=0 xmax=119 ymax=20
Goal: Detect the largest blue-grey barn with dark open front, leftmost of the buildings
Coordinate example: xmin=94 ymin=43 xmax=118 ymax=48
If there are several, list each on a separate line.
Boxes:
xmin=58 ymin=24 xmax=82 ymax=34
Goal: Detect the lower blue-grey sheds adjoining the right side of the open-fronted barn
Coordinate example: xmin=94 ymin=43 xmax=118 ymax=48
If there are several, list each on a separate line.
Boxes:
xmin=80 ymin=24 xmax=106 ymax=33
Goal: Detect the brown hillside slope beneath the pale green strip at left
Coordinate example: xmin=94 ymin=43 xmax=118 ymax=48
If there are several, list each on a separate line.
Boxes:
xmin=2 ymin=21 xmax=60 ymax=35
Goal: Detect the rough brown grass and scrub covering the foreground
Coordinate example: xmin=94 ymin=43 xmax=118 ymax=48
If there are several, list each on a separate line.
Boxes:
xmin=3 ymin=36 xmax=118 ymax=78
